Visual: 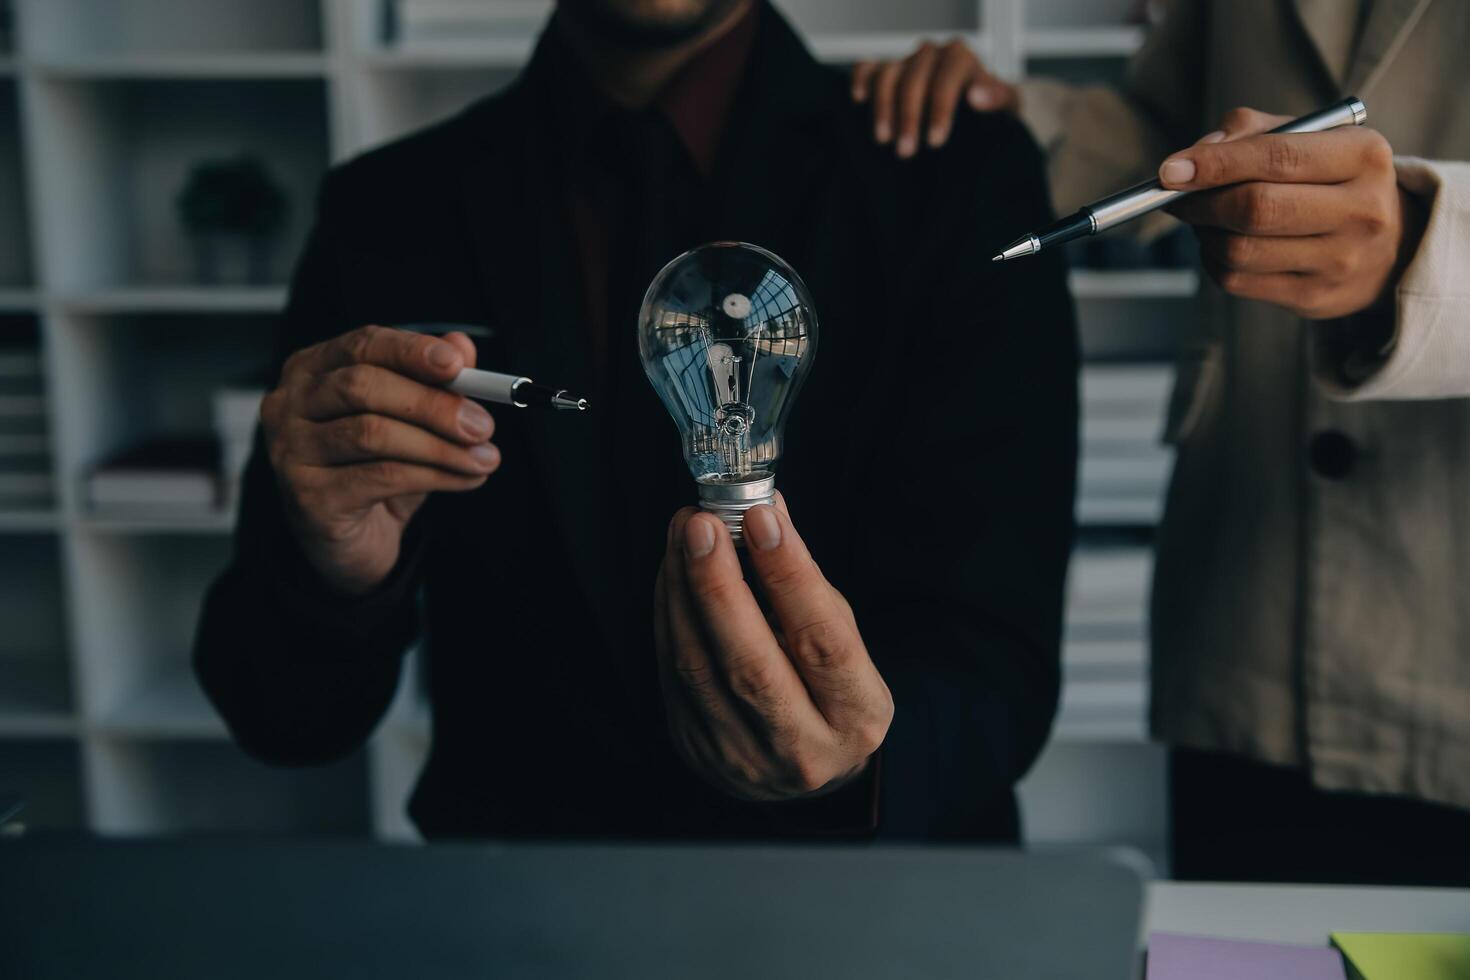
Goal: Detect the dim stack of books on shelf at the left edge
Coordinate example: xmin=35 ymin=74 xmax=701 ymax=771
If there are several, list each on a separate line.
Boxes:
xmin=0 ymin=332 xmax=54 ymax=513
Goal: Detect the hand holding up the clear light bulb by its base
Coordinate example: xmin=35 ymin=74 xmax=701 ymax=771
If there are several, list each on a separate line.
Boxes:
xmin=654 ymin=494 xmax=894 ymax=801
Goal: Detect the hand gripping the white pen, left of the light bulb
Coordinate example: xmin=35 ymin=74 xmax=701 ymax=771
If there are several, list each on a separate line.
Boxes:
xmin=260 ymin=326 xmax=500 ymax=595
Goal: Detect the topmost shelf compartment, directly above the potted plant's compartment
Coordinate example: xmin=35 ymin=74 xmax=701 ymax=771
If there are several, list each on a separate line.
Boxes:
xmin=16 ymin=0 xmax=322 ymax=59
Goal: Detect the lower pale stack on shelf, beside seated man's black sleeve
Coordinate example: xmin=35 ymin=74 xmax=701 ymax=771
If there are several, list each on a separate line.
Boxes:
xmin=1057 ymin=545 xmax=1152 ymax=741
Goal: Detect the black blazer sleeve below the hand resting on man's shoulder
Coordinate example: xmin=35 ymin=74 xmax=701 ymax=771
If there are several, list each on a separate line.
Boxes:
xmin=850 ymin=118 xmax=1078 ymax=837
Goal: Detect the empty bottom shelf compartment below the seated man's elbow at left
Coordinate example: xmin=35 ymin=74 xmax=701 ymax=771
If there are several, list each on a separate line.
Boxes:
xmin=88 ymin=736 xmax=368 ymax=836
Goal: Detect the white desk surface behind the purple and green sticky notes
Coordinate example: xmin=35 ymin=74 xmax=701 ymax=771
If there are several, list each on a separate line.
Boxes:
xmin=1144 ymin=881 xmax=1470 ymax=945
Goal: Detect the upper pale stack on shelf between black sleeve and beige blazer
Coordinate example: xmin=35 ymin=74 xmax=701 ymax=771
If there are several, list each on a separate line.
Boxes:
xmin=1078 ymin=364 xmax=1173 ymax=526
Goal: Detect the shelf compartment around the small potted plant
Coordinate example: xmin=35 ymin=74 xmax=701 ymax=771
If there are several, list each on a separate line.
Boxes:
xmin=29 ymin=76 xmax=329 ymax=295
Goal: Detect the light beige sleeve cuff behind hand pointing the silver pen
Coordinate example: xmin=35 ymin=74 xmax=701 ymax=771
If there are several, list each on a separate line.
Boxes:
xmin=1313 ymin=157 xmax=1470 ymax=401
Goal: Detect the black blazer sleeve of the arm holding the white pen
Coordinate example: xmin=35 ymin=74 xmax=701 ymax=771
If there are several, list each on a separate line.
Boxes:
xmin=194 ymin=178 xmax=423 ymax=765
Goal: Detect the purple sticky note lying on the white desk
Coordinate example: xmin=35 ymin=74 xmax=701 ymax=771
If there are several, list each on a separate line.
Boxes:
xmin=1148 ymin=933 xmax=1345 ymax=980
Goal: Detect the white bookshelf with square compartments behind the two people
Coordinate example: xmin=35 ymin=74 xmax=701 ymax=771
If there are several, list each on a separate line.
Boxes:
xmin=0 ymin=0 xmax=1176 ymax=837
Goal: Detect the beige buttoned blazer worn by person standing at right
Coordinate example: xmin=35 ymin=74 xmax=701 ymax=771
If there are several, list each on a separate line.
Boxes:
xmin=1022 ymin=0 xmax=1470 ymax=807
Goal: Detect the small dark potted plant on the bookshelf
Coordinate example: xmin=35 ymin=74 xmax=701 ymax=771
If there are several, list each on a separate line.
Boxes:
xmin=176 ymin=153 xmax=287 ymax=284
